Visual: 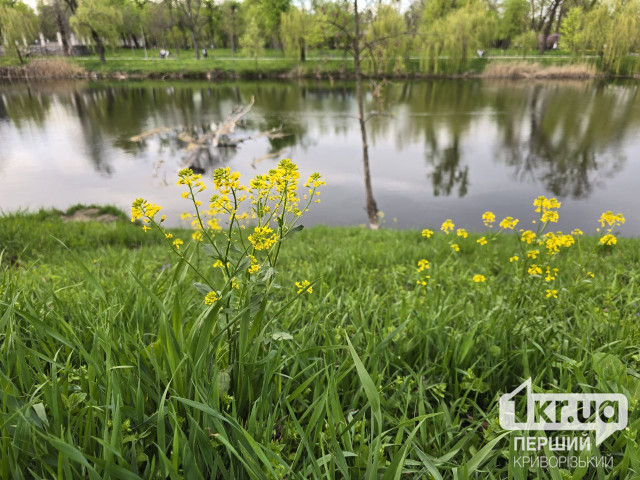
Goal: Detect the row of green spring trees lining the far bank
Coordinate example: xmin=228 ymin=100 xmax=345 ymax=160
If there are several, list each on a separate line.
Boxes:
xmin=0 ymin=0 xmax=640 ymax=73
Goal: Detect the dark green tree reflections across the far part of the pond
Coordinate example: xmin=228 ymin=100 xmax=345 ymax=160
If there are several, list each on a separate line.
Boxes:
xmin=0 ymin=80 xmax=640 ymax=219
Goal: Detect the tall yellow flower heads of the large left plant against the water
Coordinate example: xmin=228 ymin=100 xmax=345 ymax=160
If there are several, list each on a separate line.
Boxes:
xmin=131 ymin=159 xmax=326 ymax=305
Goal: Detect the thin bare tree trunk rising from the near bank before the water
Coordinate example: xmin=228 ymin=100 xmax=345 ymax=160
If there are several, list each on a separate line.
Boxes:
xmin=353 ymin=0 xmax=380 ymax=230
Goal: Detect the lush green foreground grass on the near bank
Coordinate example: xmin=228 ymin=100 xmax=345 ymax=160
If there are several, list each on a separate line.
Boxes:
xmin=0 ymin=211 xmax=640 ymax=479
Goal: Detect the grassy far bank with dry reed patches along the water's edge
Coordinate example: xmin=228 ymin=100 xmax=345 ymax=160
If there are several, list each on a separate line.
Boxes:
xmin=0 ymin=49 xmax=638 ymax=79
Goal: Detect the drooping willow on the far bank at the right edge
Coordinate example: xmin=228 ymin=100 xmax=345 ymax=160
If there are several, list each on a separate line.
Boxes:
xmin=582 ymin=0 xmax=640 ymax=73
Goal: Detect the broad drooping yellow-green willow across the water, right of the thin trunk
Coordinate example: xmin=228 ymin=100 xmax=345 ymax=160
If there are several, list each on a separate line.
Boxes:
xmin=418 ymin=0 xmax=496 ymax=73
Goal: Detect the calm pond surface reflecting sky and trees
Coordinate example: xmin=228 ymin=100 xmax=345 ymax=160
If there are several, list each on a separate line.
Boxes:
xmin=0 ymin=80 xmax=640 ymax=236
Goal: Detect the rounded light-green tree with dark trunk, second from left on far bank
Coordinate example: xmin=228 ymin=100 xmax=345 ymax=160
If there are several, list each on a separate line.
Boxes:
xmin=70 ymin=0 xmax=122 ymax=63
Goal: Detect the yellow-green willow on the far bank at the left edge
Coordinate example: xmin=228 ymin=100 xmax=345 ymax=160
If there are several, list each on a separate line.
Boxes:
xmin=0 ymin=2 xmax=36 ymax=64
